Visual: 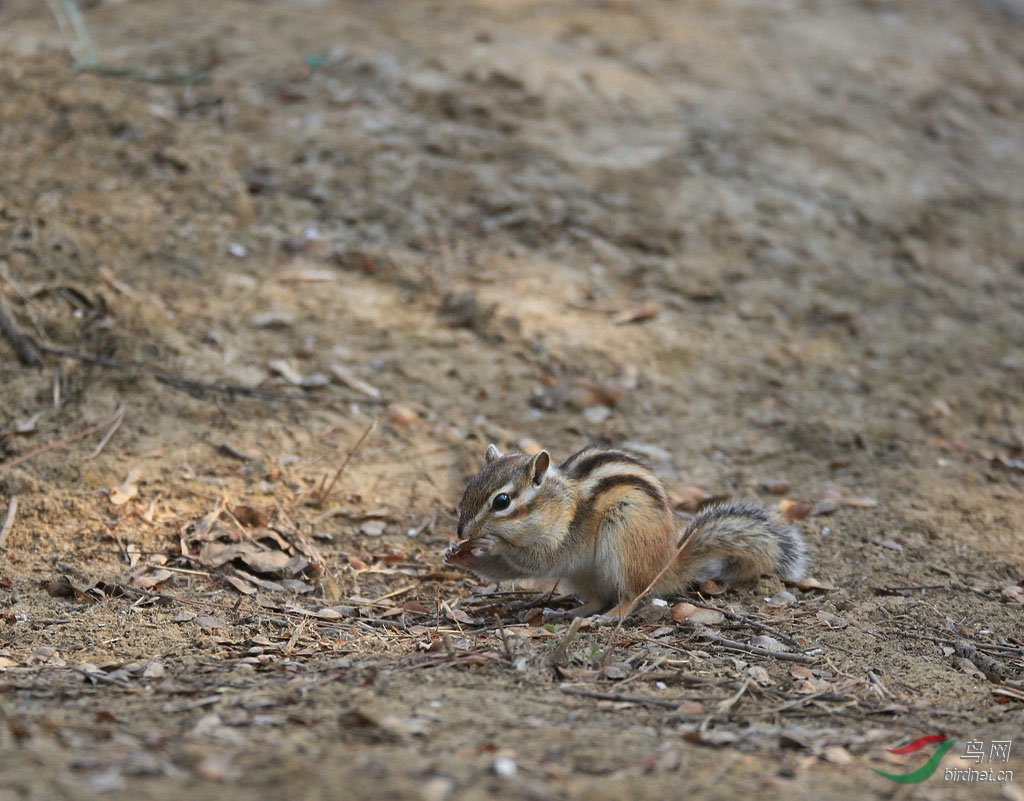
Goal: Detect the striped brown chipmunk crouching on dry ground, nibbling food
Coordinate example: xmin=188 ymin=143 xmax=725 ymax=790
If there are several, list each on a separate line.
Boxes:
xmin=444 ymin=445 xmax=807 ymax=616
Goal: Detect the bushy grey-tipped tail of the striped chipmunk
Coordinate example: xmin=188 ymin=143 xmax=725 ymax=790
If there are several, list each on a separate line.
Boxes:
xmin=675 ymin=502 xmax=807 ymax=585
